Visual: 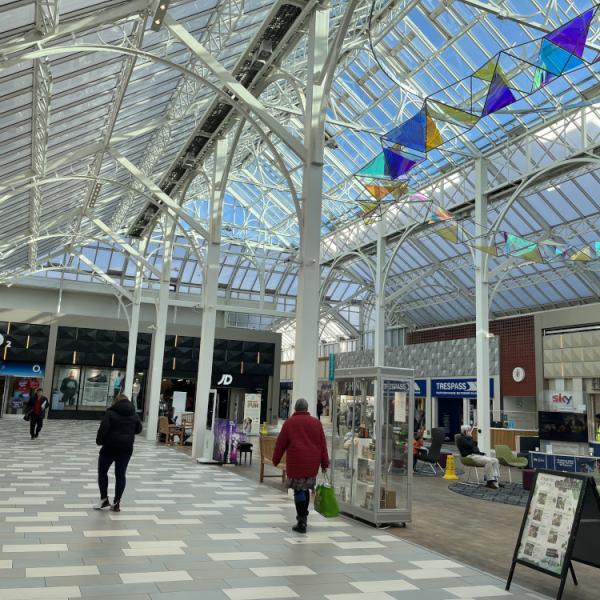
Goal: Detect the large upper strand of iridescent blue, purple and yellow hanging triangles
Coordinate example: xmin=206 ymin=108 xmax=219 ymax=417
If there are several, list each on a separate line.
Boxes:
xmin=355 ymin=5 xmax=600 ymax=198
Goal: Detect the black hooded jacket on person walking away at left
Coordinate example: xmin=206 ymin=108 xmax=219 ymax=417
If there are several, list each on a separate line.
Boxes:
xmin=96 ymin=400 xmax=142 ymax=456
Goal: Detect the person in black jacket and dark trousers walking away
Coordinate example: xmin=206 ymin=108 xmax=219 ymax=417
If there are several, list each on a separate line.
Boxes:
xmin=95 ymin=394 xmax=142 ymax=512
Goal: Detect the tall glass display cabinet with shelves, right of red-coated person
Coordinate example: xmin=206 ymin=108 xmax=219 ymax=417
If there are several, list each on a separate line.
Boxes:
xmin=331 ymin=367 xmax=414 ymax=525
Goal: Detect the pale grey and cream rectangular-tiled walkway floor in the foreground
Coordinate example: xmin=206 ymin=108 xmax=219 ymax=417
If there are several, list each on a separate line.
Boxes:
xmin=0 ymin=419 xmax=541 ymax=600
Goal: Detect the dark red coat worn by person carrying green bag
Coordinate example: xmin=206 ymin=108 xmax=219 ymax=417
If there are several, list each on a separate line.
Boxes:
xmin=273 ymin=411 xmax=329 ymax=479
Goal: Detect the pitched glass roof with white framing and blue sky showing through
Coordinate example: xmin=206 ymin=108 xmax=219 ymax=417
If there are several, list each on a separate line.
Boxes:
xmin=0 ymin=0 xmax=600 ymax=344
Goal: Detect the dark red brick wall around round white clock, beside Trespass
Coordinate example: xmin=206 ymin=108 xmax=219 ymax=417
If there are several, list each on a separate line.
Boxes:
xmin=406 ymin=316 xmax=536 ymax=396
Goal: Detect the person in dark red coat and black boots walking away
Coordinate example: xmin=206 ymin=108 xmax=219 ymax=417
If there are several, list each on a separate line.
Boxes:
xmin=273 ymin=398 xmax=329 ymax=533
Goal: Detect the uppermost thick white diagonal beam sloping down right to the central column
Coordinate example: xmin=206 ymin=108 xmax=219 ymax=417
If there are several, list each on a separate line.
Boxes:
xmin=164 ymin=15 xmax=304 ymax=158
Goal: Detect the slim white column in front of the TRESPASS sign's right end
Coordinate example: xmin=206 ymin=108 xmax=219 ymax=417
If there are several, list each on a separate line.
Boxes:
xmin=475 ymin=158 xmax=490 ymax=454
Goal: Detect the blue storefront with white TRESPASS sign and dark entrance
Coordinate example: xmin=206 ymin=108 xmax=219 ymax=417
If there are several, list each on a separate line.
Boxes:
xmin=431 ymin=377 xmax=494 ymax=442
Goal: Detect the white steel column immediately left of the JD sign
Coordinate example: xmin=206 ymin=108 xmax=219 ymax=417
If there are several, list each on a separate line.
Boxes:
xmin=192 ymin=139 xmax=227 ymax=458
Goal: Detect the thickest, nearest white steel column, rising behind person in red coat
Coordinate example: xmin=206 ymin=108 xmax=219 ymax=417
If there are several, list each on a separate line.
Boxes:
xmin=293 ymin=7 xmax=329 ymax=414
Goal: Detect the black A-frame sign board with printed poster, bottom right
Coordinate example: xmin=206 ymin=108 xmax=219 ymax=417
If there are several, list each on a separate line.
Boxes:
xmin=506 ymin=470 xmax=600 ymax=600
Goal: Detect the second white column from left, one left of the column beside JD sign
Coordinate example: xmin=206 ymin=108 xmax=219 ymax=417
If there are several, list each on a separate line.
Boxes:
xmin=146 ymin=216 xmax=177 ymax=440
